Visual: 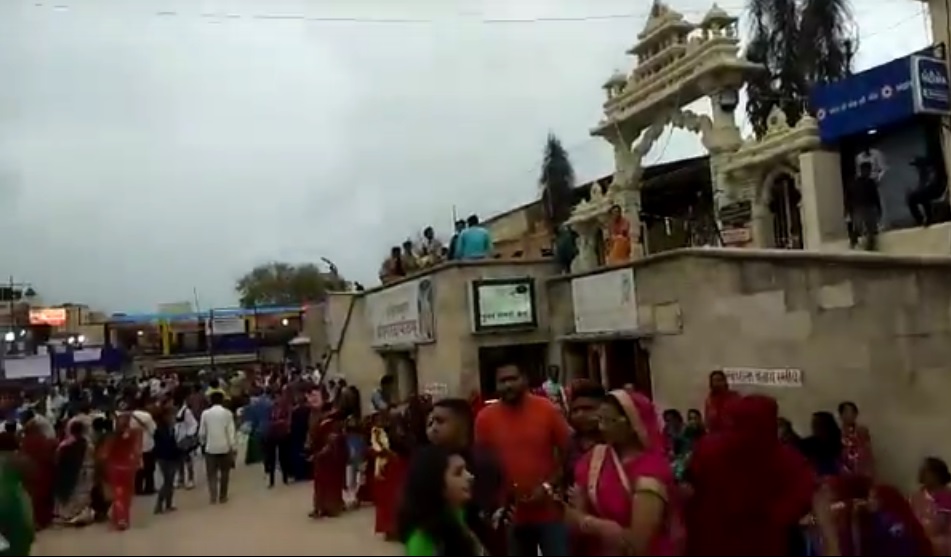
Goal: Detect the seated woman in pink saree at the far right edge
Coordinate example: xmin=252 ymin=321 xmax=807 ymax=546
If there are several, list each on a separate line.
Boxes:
xmin=911 ymin=457 xmax=951 ymax=555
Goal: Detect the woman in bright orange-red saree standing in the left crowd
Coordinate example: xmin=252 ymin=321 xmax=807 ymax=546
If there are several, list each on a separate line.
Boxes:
xmin=103 ymin=412 xmax=142 ymax=531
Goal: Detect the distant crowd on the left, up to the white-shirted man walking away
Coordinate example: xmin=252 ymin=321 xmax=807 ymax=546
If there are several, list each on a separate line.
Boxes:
xmin=0 ymin=368 xmax=317 ymax=555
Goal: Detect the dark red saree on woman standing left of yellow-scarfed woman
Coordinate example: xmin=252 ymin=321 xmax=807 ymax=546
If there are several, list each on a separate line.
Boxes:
xmin=310 ymin=412 xmax=348 ymax=518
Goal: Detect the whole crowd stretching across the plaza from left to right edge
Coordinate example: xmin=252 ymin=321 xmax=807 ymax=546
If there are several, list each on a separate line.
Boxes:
xmin=0 ymin=362 xmax=951 ymax=556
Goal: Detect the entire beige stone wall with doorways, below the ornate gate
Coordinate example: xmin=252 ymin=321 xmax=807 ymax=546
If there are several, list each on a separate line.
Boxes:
xmin=336 ymin=249 xmax=951 ymax=485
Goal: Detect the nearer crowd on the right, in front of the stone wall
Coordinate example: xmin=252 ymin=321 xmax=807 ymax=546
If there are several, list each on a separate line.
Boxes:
xmin=352 ymin=364 xmax=951 ymax=556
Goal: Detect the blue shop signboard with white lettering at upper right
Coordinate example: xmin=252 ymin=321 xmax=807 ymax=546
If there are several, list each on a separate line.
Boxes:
xmin=810 ymin=54 xmax=951 ymax=143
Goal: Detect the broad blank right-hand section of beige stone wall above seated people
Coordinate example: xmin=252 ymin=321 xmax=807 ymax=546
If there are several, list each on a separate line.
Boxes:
xmin=550 ymin=250 xmax=951 ymax=485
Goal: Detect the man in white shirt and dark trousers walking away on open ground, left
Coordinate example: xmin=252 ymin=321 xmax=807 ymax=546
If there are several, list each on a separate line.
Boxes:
xmin=198 ymin=391 xmax=238 ymax=505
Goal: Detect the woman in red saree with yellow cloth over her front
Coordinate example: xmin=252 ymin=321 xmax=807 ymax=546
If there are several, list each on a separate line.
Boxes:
xmin=368 ymin=412 xmax=409 ymax=540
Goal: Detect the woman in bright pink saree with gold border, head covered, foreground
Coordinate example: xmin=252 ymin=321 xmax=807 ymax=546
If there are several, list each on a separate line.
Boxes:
xmin=566 ymin=390 xmax=683 ymax=555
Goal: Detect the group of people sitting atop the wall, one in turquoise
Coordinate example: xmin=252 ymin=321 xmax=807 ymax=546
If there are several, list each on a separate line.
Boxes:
xmin=380 ymin=215 xmax=492 ymax=284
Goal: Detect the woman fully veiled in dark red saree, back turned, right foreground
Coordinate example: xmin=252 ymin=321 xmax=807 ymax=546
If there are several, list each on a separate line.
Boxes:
xmin=685 ymin=395 xmax=838 ymax=556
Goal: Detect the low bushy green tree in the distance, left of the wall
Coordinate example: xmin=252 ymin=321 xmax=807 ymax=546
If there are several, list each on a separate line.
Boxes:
xmin=235 ymin=262 xmax=349 ymax=307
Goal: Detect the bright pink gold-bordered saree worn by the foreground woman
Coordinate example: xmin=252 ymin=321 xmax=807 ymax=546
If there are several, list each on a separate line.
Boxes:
xmin=574 ymin=390 xmax=683 ymax=556
